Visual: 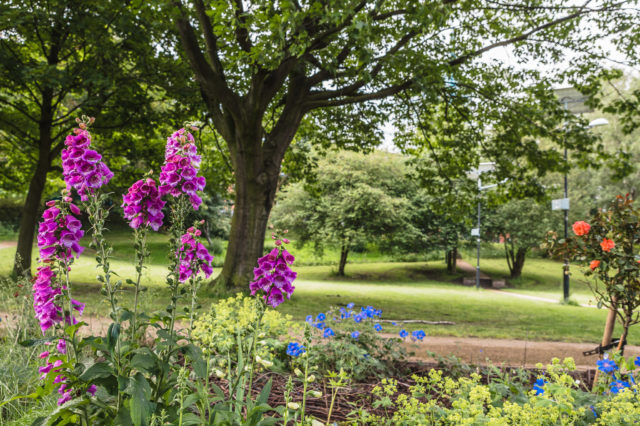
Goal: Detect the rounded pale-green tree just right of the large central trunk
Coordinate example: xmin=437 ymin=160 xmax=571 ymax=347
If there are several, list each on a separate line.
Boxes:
xmin=273 ymin=152 xmax=417 ymax=275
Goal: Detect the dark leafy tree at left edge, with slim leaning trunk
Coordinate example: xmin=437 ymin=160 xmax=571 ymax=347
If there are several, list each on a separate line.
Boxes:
xmin=0 ymin=0 xmax=195 ymax=273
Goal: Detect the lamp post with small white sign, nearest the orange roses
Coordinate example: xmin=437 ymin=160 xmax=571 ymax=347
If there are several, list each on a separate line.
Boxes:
xmin=551 ymin=87 xmax=609 ymax=302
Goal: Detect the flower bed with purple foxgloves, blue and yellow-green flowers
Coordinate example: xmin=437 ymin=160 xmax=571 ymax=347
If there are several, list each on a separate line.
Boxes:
xmin=7 ymin=118 xmax=640 ymax=426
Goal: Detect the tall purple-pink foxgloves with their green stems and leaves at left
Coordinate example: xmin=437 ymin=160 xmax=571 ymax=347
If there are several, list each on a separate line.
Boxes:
xmin=15 ymin=117 xmax=295 ymax=426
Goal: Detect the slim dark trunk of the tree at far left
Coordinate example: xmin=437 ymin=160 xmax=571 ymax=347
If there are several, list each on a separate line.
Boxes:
xmin=13 ymin=89 xmax=53 ymax=276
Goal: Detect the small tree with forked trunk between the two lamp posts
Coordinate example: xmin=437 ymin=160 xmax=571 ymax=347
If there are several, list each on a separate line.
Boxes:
xmin=483 ymin=198 xmax=559 ymax=279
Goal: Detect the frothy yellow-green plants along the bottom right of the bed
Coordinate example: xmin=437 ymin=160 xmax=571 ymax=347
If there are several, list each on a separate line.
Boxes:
xmin=358 ymin=358 xmax=608 ymax=425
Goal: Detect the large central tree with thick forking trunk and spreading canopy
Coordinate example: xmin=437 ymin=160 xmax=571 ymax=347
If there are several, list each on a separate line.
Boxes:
xmin=168 ymin=0 xmax=637 ymax=286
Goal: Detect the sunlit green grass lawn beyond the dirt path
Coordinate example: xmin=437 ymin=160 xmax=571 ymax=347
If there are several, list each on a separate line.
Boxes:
xmin=0 ymin=234 xmax=624 ymax=344
